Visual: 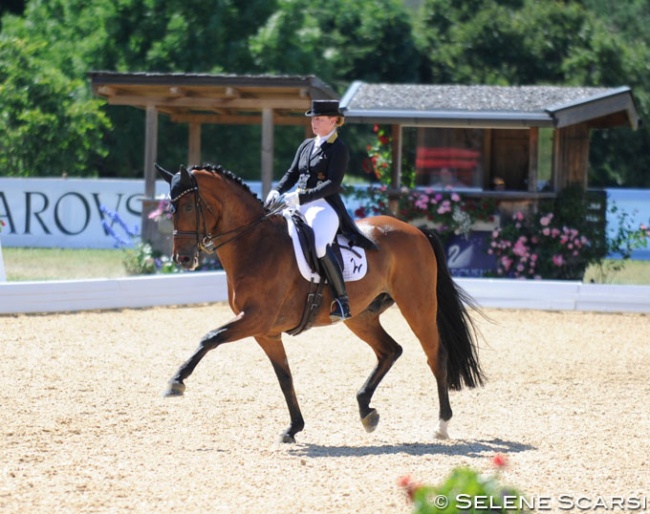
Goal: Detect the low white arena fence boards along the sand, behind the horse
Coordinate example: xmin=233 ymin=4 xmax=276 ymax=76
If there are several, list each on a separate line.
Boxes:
xmin=0 ymin=271 xmax=650 ymax=314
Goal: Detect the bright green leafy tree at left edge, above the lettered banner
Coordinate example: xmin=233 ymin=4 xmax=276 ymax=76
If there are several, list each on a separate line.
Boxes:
xmin=0 ymin=36 xmax=110 ymax=176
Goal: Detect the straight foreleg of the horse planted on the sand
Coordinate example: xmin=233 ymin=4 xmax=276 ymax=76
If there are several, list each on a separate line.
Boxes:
xmin=255 ymin=334 xmax=305 ymax=443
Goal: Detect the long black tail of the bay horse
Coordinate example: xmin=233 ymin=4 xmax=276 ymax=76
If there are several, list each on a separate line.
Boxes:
xmin=422 ymin=230 xmax=484 ymax=390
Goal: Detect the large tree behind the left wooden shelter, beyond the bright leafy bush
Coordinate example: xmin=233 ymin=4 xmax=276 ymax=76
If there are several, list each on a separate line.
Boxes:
xmin=3 ymin=0 xmax=275 ymax=177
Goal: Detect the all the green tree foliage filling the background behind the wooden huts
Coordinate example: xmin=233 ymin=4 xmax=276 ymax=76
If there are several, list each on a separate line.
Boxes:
xmin=0 ymin=0 xmax=650 ymax=186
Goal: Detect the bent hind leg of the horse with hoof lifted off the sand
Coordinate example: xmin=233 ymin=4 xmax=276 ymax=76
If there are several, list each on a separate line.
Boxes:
xmin=345 ymin=311 xmax=402 ymax=432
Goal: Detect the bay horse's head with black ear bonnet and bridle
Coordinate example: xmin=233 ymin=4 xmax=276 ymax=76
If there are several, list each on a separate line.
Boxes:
xmin=155 ymin=164 xmax=206 ymax=270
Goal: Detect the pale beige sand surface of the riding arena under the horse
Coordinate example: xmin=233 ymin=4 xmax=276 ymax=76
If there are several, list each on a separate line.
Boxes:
xmin=0 ymin=304 xmax=650 ymax=514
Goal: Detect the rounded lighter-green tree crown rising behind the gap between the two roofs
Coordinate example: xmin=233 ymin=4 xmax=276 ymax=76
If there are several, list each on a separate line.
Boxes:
xmin=250 ymin=0 xmax=421 ymax=85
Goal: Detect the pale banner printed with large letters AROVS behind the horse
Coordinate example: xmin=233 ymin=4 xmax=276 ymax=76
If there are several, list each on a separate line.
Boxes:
xmin=0 ymin=178 xmax=169 ymax=248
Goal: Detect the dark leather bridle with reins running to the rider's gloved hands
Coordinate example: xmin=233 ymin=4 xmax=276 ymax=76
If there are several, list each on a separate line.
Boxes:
xmin=170 ymin=175 xmax=283 ymax=254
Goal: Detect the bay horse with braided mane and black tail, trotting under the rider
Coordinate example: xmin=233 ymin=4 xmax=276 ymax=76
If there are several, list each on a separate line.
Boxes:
xmin=156 ymin=164 xmax=484 ymax=443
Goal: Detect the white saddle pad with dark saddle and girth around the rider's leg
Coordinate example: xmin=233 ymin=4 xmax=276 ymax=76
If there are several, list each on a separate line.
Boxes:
xmin=283 ymin=209 xmax=367 ymax=335
